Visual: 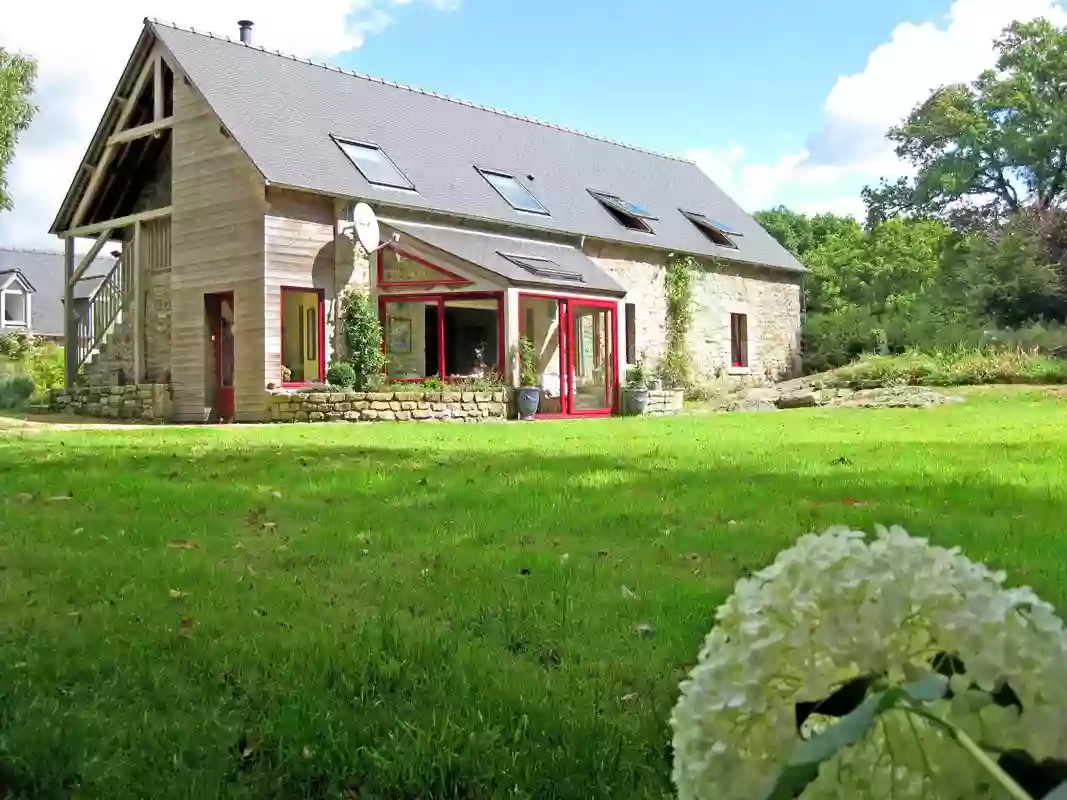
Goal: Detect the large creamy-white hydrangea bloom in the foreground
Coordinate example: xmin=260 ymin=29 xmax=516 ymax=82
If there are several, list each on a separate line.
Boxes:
xmin=671 ymin=528 xmax=1067 ymax=800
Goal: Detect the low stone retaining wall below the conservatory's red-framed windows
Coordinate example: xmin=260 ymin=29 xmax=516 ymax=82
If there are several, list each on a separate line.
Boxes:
xmin=267 ymin=391 xmax=508 ymax=422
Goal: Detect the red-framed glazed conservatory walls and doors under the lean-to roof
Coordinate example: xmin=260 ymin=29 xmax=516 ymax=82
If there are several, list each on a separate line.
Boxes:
xmin=376 ymin=241 xmax=619 ymax=418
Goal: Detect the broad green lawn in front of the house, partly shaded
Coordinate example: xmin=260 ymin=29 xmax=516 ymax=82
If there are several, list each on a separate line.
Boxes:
xmin=0 ymin=391 xmax=1067 ymax=799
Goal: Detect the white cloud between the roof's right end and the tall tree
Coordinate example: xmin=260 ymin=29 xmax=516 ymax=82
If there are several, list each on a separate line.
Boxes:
xmin=687 ymin=0 xmax=1067 ymax=213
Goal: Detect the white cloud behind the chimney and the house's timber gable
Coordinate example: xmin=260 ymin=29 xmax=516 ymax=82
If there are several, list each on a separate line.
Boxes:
xmin=0 ymin=0 xmax=460 ymax=247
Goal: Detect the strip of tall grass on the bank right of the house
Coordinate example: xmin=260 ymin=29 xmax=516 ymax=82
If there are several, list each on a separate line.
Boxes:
xmin=815 ymin=348 xmax=1067 ymax=388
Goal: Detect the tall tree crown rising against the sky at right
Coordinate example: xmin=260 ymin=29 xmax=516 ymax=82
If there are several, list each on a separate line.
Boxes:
xmin=863 ymin=19 xmax=1067 ymax=227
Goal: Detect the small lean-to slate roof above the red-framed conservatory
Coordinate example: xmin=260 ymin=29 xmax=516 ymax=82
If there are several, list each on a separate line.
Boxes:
xmin=382 ymin=218 xmax=626 ymax=294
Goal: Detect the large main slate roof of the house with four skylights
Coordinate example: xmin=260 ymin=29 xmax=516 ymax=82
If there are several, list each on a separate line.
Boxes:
xmin=146 ymin=20 xmax=803 ymax=271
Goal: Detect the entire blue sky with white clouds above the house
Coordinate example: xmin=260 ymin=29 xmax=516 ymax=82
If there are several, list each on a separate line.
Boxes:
xmin=0 ymin=0 xmax=1067 ymax=247
